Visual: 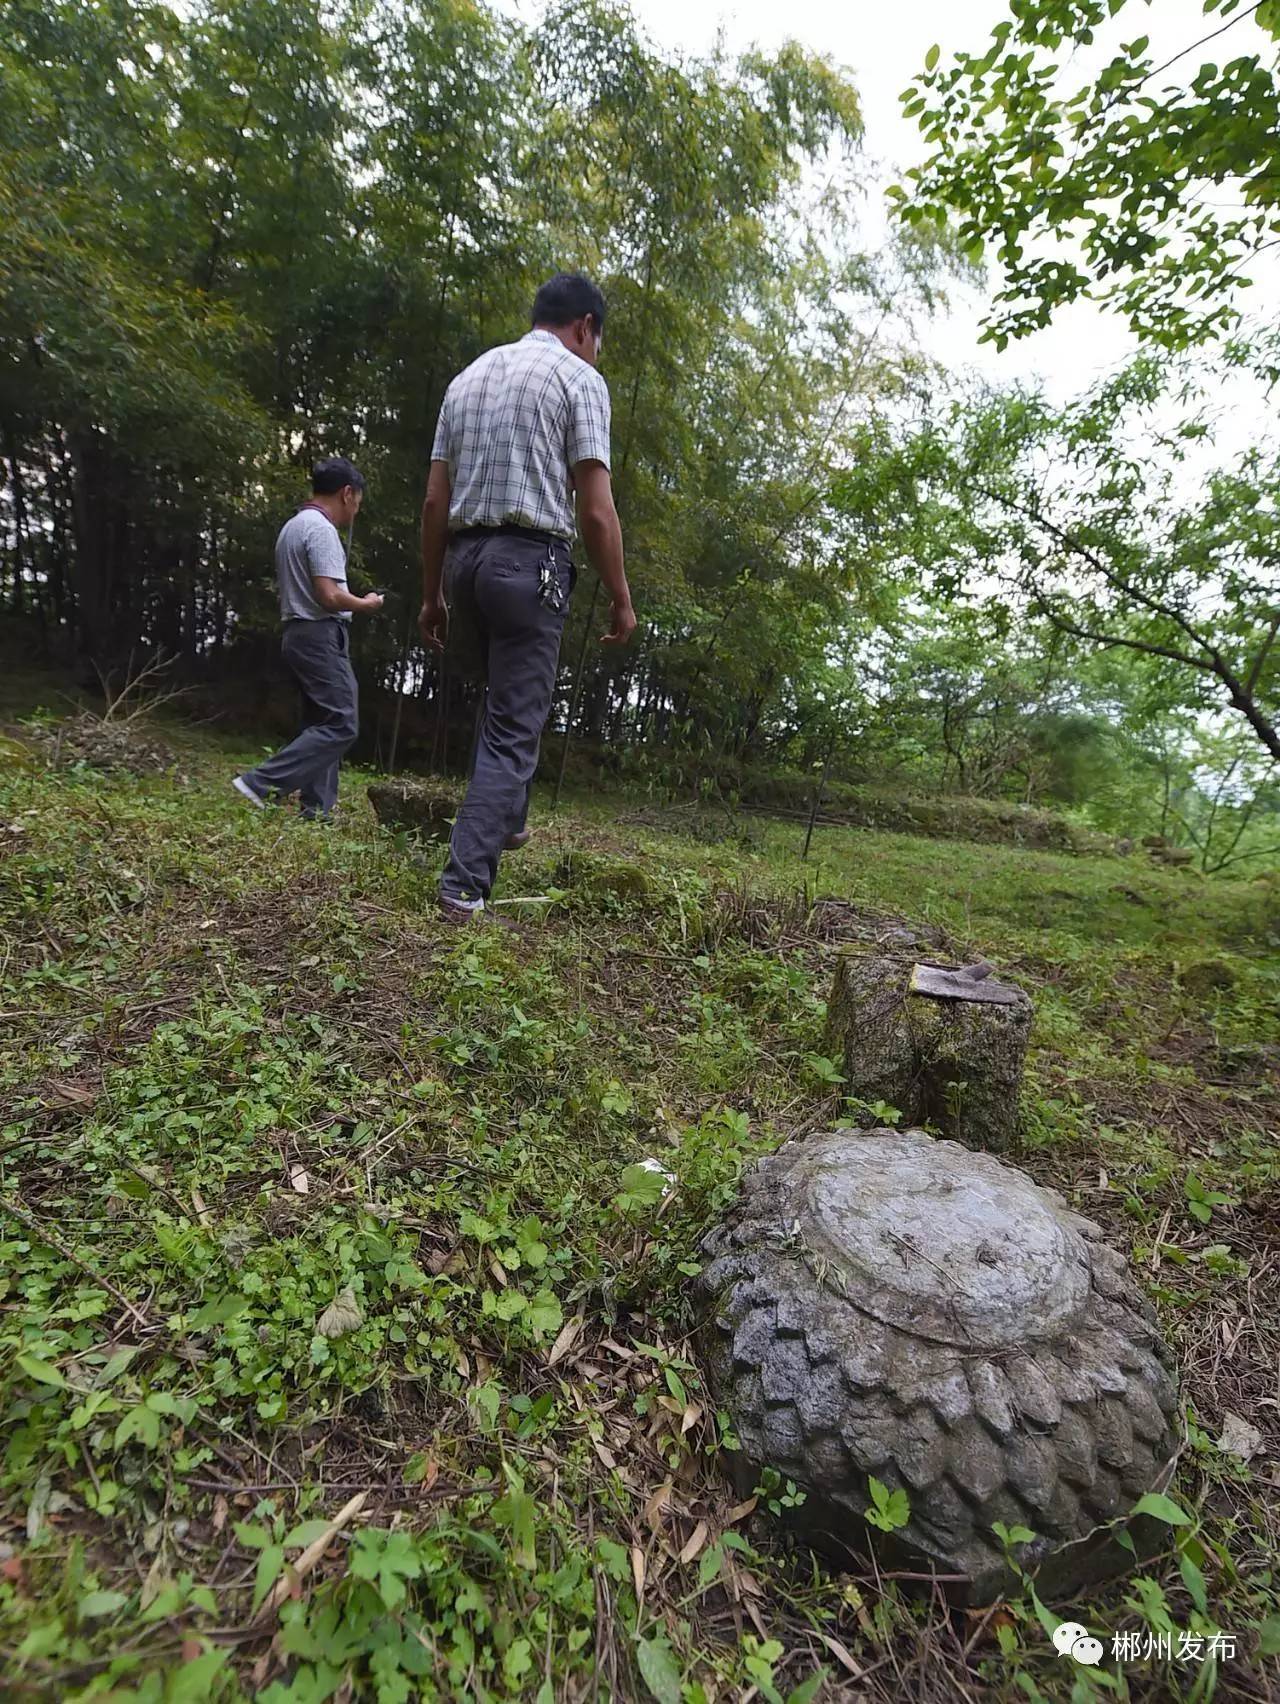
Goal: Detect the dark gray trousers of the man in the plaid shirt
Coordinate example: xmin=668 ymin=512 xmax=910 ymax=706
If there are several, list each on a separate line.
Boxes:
xmin=440 ymin=533 xmax=576 ymax=900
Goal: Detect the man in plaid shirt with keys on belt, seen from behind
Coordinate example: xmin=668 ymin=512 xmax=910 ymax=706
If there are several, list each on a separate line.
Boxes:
xmin=419 ymin=273 xmax=636 ymax=922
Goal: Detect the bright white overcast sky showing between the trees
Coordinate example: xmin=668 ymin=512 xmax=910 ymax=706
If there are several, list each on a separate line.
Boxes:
xmin=508 ymin=0 xmax=1280 ymax=424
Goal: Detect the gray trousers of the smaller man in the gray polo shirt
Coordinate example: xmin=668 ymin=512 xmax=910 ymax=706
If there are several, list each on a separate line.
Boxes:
xmin=244 ymin=617 xmax=360 ymax=816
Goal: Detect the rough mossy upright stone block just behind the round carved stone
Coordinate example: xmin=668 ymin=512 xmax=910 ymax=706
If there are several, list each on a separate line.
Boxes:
xmin=827 ymin=951 xmax=1033 ymax=1154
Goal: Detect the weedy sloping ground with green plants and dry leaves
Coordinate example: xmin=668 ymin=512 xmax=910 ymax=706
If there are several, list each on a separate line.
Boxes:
xmin=0 ymin=695 xmax=1280 ymax=1704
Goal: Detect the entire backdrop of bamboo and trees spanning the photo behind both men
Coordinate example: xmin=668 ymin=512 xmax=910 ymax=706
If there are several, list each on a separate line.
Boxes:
xmin=0 ymin=0 xmax=1280 ymax=867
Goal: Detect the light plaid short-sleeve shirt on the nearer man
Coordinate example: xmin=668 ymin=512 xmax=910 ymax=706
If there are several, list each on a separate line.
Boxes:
xmin=431 ymin=331 xmax=610 ymax=538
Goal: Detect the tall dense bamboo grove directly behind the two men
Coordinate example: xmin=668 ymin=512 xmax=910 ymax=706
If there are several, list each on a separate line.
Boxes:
xmin=0 ymin=0 xmax=934 ymax=773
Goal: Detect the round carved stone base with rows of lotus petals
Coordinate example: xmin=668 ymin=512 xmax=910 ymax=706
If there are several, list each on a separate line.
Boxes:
xmin=695 ymin=1130 xmax=1176 ymax=1602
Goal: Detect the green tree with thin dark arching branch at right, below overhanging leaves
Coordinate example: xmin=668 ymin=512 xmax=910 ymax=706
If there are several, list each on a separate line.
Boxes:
xmin=840 ymin=351 xmax=1280 ymax=762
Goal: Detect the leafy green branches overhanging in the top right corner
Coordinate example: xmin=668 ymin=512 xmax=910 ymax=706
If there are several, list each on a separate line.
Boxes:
xmin=893 ymin=0 xmax=1280 ymax=348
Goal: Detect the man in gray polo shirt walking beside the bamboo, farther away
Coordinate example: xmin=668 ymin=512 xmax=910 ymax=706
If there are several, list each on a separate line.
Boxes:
xmin=232 ymin=455 xmax=382 ymax=820
